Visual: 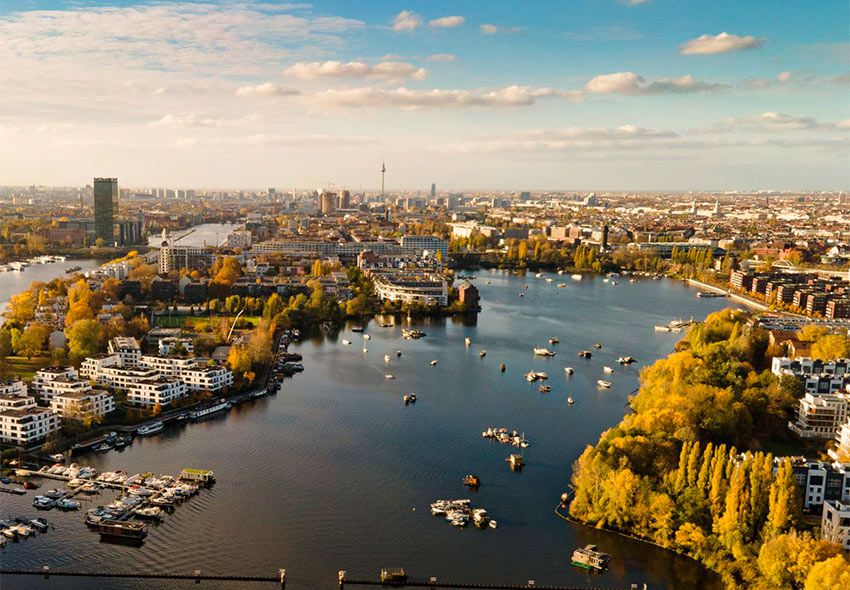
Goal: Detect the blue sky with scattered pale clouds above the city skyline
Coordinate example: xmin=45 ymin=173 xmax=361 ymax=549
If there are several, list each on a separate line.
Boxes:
xmin=0 ymin=0 xmax=850 ymax=191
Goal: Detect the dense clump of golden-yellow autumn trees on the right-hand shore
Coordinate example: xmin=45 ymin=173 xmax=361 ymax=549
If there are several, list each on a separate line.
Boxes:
xmin=570 ymin=310 xmax=850 ymax=590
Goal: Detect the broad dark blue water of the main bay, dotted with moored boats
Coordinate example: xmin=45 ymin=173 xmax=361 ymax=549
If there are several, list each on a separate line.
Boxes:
xmin=0 ymin=271 xmax=727 ymax=590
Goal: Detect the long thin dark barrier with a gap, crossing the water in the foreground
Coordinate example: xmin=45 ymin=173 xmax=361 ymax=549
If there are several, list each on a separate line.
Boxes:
xmin=0 ymin=566 xmax=646 ymax=590
